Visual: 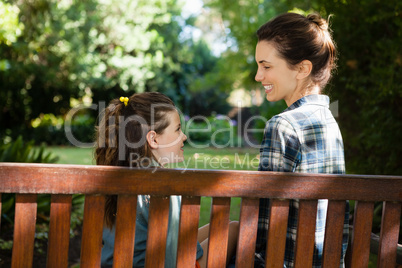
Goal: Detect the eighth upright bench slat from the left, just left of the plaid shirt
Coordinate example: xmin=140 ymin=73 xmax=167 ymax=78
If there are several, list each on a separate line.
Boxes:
xmin=236 ymin=198 xmax=259 ymax=268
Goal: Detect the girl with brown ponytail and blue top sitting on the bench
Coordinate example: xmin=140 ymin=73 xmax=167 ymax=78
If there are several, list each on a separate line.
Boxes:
xmin=95 ymin=92 xmax=236 ymax=268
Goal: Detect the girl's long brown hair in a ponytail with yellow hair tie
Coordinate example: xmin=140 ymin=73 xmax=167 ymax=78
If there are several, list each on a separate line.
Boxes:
xmin=95 ymin=92 xmax=177 ymax=228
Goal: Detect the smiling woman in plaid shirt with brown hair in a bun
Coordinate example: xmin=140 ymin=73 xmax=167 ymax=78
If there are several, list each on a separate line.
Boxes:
xmin=255 ymin=13 xmax=349 ymax=267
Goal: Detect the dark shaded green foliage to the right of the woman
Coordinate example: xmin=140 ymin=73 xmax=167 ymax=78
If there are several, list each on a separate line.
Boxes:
xmin=318 ymin=0 xmax=402 ymax=175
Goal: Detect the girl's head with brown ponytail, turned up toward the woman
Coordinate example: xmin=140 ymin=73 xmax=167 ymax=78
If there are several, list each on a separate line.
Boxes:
xmin=95 ymin=92 xmax=186 ymax=167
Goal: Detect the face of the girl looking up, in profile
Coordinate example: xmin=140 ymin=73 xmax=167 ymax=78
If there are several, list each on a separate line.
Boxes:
xmin=152 ymin=111 xmax=187 ymax=165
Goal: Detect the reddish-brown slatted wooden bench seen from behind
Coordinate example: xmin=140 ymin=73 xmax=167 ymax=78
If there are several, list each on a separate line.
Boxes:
xmin=0 ymin=163 xmax=402 ymax=268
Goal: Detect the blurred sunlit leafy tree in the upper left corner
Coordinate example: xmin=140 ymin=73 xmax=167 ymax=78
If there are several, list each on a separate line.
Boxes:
xmin=0 ymin=0 xmax=181 ymax=133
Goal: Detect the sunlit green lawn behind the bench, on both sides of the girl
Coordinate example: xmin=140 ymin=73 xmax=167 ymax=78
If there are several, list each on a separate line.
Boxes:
xmin=46 ymin=146 xmax=259 ymax=226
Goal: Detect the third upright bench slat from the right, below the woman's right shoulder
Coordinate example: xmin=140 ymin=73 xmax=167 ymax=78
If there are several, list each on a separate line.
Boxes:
xmin=322 ymin=200 xmax=346 ymax=268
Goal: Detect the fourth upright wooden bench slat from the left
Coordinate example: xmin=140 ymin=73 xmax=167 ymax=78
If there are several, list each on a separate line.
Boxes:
xmin=113 ymin=195 xmax=137 ymax=268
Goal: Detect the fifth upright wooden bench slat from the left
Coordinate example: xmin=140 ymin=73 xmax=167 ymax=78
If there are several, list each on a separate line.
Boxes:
xmin=145 ymin=196 xmax=170 ymax=268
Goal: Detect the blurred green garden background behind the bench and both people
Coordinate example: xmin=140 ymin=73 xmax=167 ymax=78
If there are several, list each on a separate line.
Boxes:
xmin=0 ymin=0 xmax=402 ymax=264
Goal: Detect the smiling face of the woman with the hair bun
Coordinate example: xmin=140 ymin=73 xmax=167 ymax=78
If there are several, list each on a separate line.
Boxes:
xmin=255 ymin=41 xmax=300 ymax=106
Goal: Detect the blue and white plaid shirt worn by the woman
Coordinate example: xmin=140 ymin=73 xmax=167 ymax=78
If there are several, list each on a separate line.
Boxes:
xmin=256 ymin=95 xmax=349 ymax=268
